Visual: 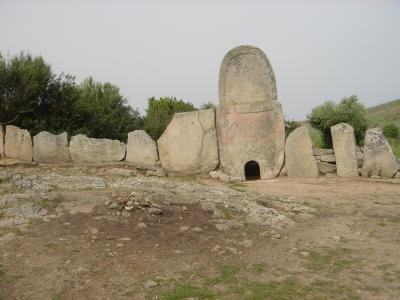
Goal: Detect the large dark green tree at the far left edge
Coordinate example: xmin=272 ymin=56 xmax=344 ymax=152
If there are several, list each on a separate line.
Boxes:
xmin=0 ymin=52 xmax=77 ymax=134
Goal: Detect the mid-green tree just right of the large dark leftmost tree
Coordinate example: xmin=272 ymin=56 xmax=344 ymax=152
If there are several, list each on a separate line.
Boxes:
xmin=74 ymin=77 xmax=143 ymax=141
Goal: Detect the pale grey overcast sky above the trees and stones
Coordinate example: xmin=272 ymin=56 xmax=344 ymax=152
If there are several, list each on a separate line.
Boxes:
xmin=0 ymin=0 xmax=400 ymax=119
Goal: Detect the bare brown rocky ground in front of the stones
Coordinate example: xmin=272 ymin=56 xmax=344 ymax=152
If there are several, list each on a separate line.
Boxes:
xmin=0 ymin=166 xmax=400 ymax=299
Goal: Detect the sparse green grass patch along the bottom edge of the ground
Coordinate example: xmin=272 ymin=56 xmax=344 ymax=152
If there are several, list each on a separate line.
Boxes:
xmin=147 ymin=264 xmax=359 ymax=300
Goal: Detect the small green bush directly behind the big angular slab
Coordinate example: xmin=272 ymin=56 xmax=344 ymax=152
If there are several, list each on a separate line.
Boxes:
xmin=144 ymin=97 xmax=196 ymax=140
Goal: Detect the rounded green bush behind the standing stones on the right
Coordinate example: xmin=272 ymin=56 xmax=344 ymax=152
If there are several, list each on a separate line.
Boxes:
xmin=307 ymin=95 xmax=367 ymax=146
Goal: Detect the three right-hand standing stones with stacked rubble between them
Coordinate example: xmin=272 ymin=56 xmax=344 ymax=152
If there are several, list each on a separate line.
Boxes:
xmin=285 ymin=123 xmax=400 ymax=178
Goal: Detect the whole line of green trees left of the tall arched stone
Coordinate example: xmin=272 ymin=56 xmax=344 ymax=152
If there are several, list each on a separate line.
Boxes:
xmin=0 ymin=53 xmax=213 ymax=141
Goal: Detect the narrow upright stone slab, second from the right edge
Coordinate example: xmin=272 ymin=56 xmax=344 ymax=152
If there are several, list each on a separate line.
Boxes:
xmin=331 ymin=123 xmax=358 ymax=178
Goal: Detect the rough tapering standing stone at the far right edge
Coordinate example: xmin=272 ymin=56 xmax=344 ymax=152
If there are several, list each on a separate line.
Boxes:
xmin=361 ymin=128 xmax=400 ymax=178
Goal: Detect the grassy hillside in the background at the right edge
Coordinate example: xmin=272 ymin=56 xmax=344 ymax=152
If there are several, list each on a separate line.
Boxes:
xmin=367 ymin=99 xmax=400 ymax=127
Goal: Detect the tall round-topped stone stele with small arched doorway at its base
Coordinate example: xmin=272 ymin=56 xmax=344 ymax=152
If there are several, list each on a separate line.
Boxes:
xmin=217 ymin=46 xmax=285 ymax=179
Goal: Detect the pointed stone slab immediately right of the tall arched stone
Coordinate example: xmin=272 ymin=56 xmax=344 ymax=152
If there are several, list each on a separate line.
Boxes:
xmin=285 ymin=125 xmax=318 ymax=178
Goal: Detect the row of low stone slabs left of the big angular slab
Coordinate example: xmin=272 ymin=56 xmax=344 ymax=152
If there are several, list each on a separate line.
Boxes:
xmin=0 ymin=125 xmax=158 ymax=166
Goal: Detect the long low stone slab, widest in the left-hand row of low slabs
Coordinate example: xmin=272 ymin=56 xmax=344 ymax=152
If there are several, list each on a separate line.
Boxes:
xmin=69 ymin=134 xmax=126 ymax=163
